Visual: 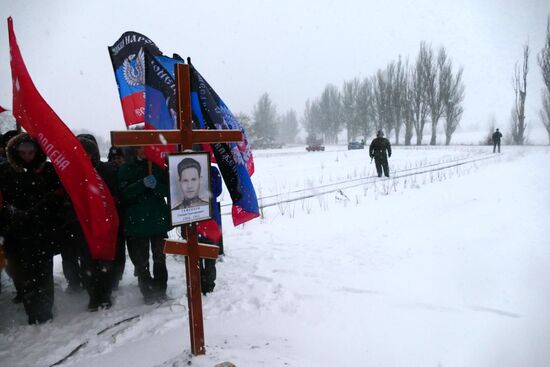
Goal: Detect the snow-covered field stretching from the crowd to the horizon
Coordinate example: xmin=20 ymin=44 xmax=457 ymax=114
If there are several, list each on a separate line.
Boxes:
xmin=0 ymin=146 xmax=550 ymax=367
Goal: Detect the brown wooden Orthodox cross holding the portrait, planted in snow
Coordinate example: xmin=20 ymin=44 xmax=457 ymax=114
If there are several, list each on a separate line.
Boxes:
xmin=111 ymin=64 xmax=243 ymax=355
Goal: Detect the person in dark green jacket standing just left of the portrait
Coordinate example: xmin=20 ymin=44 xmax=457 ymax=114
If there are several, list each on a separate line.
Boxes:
xmin=118 ymin=147 xmax=171 ymax=304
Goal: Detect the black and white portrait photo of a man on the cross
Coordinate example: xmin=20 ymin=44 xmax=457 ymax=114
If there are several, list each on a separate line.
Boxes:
xmin=168 ymin=153 xmax=211 ymax=225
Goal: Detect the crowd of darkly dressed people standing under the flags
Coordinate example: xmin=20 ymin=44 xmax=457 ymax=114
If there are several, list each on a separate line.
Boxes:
xmin=0 ymin=130 xmax=221 ymax=324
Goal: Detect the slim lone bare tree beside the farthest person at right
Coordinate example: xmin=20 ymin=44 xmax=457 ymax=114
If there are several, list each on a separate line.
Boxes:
xmin=512 ymin=43 xmax=529 ymax=145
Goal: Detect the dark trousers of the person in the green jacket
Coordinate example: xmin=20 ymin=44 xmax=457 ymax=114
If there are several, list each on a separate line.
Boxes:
xmin=126 ymin=234 xmax=168 ymax=298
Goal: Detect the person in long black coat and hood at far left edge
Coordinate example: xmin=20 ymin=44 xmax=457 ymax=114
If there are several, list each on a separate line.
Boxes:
xmin=0 ymin=133 xmax=62 ymax=324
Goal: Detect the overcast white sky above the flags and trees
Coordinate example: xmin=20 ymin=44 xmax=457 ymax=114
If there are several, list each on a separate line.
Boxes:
xmin=0 ymin=0 xmax=550 ymax=140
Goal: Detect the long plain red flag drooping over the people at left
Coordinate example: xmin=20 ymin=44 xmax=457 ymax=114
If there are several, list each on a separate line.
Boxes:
xmin=8 ymin=17 xmax=118 ymax=260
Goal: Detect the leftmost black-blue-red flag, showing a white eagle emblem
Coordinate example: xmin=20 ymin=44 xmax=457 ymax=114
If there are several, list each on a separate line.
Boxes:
xmin=108 ymin=32 xmax=162 ymax=127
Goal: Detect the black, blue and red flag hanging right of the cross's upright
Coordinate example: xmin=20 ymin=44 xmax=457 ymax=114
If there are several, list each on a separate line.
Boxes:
xmin=188 ymin=59 xmax=259 ymax=225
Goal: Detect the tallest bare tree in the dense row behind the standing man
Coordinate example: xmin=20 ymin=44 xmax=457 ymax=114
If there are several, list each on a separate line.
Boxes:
xmin=410 ymin=42 xmax=429 ymax=145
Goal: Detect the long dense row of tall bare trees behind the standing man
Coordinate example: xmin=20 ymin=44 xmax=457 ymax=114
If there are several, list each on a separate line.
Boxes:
xmin=302 ymin=42 xmax=464 ymax=145
